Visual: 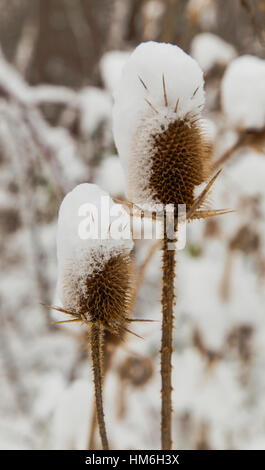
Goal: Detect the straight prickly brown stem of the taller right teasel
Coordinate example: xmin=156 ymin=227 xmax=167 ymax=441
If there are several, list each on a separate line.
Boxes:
xmin=161 ymin=235 xmax=176 ymax=450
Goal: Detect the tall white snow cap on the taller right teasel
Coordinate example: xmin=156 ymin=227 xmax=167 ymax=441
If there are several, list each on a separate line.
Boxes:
xmin=113 ymin=41 xmax=204 ymax=207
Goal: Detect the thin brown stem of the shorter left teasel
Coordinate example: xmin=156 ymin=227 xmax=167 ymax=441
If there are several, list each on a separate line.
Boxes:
xmin=90 ymin=323 xmax=109 ymax=450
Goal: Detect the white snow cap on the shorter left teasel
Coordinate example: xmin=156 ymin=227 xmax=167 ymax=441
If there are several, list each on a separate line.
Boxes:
xmin=57 ymin=183 xmax=133 ymax=308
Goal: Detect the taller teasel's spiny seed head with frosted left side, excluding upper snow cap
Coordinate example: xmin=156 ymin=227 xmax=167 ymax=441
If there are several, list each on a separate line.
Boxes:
xmin=128 ymin=111 xmax=213 ymax=211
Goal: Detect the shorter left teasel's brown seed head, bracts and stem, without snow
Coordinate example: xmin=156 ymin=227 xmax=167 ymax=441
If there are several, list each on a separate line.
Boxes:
xmin=42 ymin=253 xmax=135 ymax=450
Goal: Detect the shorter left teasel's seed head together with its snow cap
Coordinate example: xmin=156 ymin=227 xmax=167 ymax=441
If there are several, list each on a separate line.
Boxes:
xmin=57 ymin=184 xmax=133 ymax=333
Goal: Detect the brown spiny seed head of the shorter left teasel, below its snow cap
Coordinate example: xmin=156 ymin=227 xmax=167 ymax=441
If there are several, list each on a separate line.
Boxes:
xmin=60 ymin=253 xmax=134 ymax=335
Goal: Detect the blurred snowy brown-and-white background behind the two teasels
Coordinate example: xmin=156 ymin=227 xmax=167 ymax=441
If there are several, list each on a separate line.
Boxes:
xmin=0 ymin=0 xmax=265 ymax=449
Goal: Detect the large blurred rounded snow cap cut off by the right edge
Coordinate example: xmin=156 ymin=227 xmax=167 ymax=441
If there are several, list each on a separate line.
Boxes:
xmin=221 ymin=55 xmax=265 ymax=129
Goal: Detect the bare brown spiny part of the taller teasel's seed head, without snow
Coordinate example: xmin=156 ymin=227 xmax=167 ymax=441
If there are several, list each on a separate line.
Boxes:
xmin=149 ymin=119 xmax=212 ymax=210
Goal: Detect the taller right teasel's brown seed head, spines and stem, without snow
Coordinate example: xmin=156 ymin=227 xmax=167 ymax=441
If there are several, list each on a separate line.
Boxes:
xmin=120 ymin=74 xmax=229 ymax=449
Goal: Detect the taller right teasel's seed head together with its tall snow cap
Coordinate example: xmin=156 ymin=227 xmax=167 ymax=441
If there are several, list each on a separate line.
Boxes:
xmin=113 ymin=42 xmax=211 ymax=208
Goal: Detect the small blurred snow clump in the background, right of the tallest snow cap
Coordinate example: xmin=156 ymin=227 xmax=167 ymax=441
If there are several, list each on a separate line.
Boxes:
xmin=191 ymin=33 xmax=237 ymax=72
